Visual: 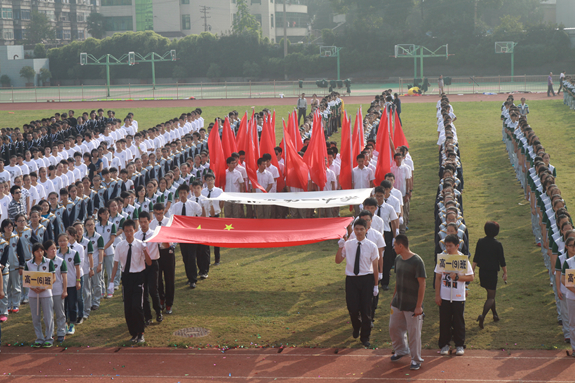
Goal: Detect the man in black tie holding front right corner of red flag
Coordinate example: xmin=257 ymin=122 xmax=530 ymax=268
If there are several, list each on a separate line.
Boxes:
xmin=335 ymin=218 xmax=379 ymax=347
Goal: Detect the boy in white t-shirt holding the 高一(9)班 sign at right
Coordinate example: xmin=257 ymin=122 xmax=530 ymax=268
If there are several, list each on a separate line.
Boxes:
xmin=434 ymin=234 xmax=474 ymax=355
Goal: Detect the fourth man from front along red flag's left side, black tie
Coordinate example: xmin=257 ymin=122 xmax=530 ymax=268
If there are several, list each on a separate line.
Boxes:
xmin=172 ymin=184 xmax=204 ymax=289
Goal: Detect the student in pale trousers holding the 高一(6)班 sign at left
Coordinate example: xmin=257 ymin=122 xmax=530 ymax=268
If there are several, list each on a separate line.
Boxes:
xmin=24 ymin=243 xmax=55 ymax=347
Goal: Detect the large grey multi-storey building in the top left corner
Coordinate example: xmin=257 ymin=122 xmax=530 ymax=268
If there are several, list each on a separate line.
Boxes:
xmin=0 ymin=0 xmax=99 ymax=45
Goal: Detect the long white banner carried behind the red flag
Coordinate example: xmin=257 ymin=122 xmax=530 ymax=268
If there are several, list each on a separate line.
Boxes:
xmin=209 ymin=189 xmax=373 ymax=209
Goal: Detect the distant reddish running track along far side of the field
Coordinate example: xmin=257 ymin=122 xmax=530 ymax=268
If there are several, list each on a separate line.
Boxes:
xmin=0 ymin=93 xmax=562 ymax=111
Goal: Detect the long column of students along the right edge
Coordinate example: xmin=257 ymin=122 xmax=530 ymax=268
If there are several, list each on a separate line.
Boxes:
xmin=501 ymin=94 xmax=575 ymax=351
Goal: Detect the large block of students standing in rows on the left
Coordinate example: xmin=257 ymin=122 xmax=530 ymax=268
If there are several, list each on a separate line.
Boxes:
xmin=0 ymin=109 xmax=221 ymax=347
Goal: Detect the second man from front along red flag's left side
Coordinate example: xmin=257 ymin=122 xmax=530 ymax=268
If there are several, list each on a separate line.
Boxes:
xmin=134 ymin=211 xmax=164 ymax=326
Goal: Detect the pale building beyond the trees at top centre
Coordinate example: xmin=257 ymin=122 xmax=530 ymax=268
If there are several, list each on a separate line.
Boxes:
xmin=100 ymin=0 xmax=309 ymax=42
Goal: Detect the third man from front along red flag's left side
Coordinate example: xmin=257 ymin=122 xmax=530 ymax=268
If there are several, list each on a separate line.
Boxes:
xmin=150 ymin=203 xmax=176 ymax=314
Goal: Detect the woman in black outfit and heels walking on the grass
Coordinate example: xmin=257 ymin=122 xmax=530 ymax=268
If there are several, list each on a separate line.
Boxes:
xmin=473 ymin=221 xmax=507 ymax=329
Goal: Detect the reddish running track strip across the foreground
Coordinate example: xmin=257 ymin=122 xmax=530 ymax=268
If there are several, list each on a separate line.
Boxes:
xmin=0 ymin=347 xmax=575 ymax=383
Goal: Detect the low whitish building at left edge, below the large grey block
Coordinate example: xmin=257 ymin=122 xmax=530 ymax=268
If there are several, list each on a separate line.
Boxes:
xmin=0 ymin=45 xmax=49 ymax=88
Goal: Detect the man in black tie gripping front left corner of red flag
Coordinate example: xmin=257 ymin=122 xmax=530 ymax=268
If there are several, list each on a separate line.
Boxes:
xmin=108 ymin=219 xmax=151 ymax=343
